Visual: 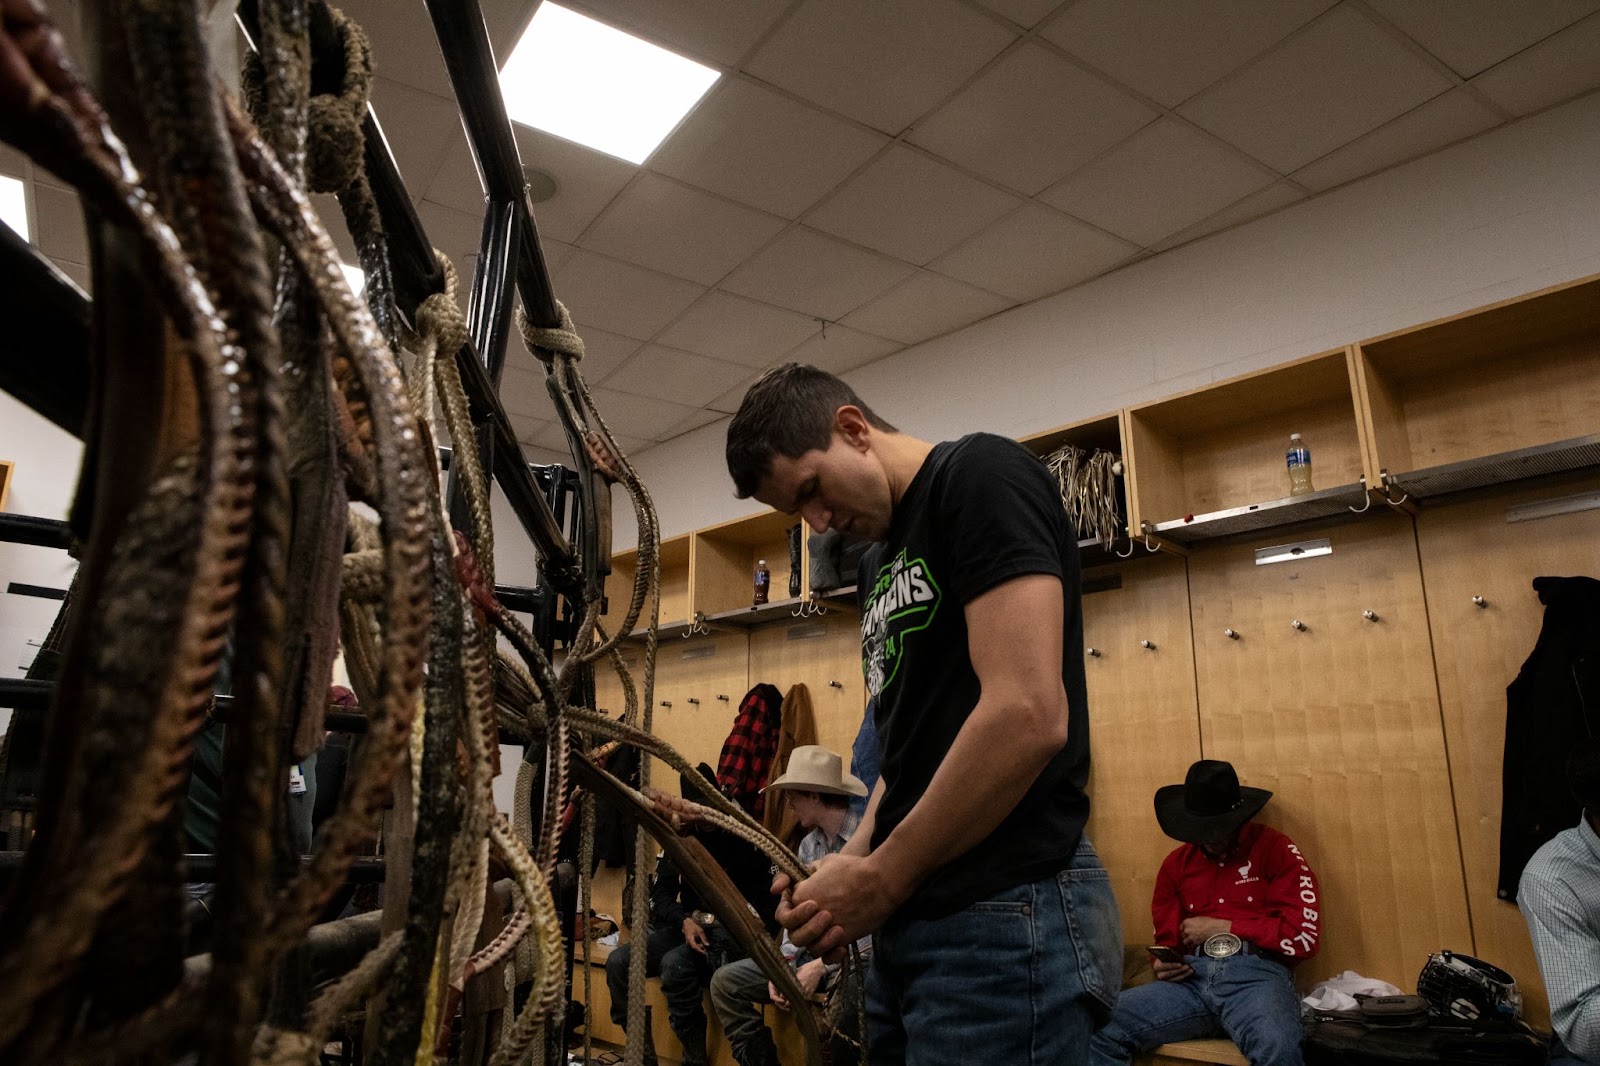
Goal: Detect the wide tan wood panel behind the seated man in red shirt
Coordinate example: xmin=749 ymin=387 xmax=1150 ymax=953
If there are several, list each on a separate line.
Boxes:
xmin=1189 ymin=515 xmax=1470 ymax=988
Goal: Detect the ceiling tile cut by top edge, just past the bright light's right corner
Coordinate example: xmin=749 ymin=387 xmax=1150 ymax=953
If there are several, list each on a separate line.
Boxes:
xmin=746 ymin=0 xmax=1014 ymax=133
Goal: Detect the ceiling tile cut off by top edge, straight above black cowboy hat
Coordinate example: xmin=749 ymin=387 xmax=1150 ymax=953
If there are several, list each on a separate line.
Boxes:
xmin=1042 ymin=0 xmax=1334 ymax=107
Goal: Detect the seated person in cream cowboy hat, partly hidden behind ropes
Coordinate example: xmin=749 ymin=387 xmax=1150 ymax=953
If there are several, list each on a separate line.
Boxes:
xmin=710 ymin=744 xmax=872 ymax=1066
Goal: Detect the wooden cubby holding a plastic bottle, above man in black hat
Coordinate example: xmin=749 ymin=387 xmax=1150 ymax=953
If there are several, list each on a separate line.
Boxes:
xmin=1126 ymin=347 xmax=1366 ymax=544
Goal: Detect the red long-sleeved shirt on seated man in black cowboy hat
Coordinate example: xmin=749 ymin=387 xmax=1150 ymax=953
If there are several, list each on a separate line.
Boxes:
xmin=1150 ymin=821 xmax=1322 ymax=960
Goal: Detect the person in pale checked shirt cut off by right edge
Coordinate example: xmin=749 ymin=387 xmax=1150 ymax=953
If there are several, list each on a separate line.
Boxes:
xmin=1517 ymin=739 xmax=1600 ymax=1066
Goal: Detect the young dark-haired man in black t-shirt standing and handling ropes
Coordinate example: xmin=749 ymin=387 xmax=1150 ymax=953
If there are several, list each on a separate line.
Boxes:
xmin=728 ymin=363 xmax=1122 ymax=1066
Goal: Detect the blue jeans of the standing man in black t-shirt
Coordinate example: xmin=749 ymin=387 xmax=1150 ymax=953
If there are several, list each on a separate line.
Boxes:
xmin=867 ymin=837 xmax=1122 ymax=1066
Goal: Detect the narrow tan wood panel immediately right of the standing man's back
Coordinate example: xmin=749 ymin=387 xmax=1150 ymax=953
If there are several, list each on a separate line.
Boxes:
xmin=1083 ymin=555 xmax=1200 ymax=944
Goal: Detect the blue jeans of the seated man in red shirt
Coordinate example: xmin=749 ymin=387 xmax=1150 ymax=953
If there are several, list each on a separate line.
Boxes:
xmin=1093 ymin=956 xmax=1306 ymax=1066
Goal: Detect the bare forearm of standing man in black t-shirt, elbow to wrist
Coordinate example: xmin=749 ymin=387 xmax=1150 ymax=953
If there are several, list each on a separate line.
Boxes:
xmin=874 ymin=693 xmax=1066 ymax=895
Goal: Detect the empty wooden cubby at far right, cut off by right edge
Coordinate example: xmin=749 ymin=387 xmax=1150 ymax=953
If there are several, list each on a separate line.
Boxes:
xmin=1357 ymin=279 xmax=1600 ymax=499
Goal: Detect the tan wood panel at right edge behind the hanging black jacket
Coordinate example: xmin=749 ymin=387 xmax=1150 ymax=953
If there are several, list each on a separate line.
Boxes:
xmin=1416 ymin=474 xmax=1600 ymax=1024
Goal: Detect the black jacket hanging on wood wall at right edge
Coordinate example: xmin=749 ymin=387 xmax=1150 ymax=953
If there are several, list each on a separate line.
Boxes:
xmin=1499 ymin=578 xmax=1600 ymax=901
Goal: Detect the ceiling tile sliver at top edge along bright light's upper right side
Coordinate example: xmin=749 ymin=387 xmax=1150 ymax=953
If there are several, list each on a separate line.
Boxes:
xmin=566 ymin=0 xmax=789 ymax=67
